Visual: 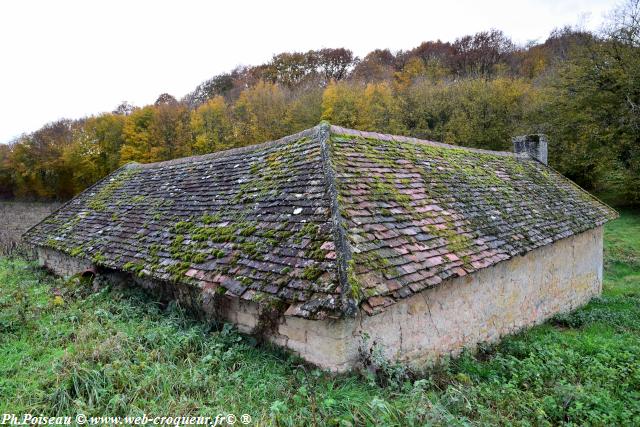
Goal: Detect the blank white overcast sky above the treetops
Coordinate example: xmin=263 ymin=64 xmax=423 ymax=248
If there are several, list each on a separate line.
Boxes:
xmin=0 ymin=0 xmax=617 ymax=142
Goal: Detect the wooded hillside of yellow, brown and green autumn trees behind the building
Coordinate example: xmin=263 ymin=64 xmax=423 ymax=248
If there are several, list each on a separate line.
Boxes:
xmin=0 ymin=0 xmax=640 ymax=204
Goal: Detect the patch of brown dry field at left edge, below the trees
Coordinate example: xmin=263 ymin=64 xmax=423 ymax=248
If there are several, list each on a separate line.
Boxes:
xmin=0 ymin=201 xmax=60 ymax=254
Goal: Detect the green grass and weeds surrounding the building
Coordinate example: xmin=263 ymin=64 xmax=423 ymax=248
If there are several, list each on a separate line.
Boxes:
xmin=0 ymin=212 xmax=640 ymax=426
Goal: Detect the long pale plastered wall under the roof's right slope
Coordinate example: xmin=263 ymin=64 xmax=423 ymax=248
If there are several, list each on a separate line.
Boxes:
xmin=348 ymin=227 xmax=602 ymax=370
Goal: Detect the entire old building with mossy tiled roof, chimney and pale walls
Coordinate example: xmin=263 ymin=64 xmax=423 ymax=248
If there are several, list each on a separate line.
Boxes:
xmin=25 ymin=123 xmax=616 ymax=371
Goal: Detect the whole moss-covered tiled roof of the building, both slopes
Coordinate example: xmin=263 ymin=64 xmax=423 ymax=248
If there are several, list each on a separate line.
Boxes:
xmin=25 ymin=124 xmax=616 ymax=318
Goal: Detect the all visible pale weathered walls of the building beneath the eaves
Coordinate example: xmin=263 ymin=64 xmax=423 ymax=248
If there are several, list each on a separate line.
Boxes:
xmin=33 ymin=227 xmax=602 ymax=371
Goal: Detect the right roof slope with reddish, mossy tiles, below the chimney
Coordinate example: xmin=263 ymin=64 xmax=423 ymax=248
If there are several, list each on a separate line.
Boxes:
xmin=331 ymin=127 xmax=616 ymax=307
